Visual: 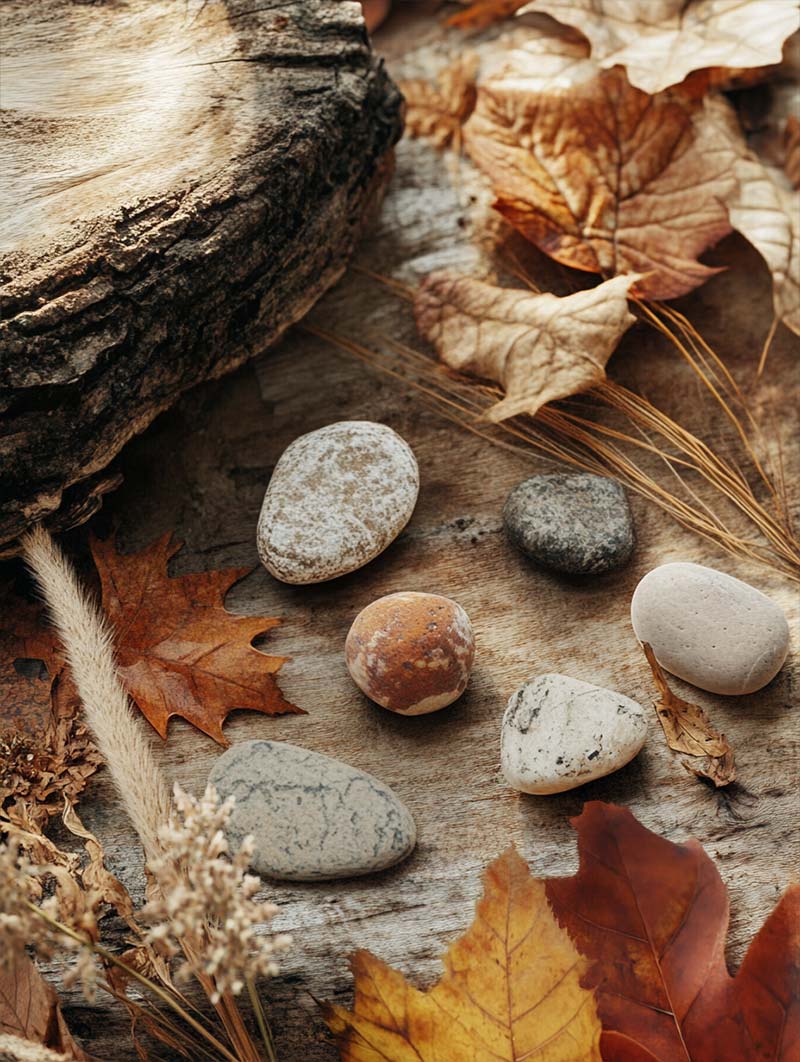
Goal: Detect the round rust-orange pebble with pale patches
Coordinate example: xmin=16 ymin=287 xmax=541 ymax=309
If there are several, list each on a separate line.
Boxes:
xmin=344 ymin=592 xmax=475 ymax=716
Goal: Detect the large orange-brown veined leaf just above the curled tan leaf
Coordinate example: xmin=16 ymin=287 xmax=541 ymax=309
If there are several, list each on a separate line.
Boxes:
xmin=463 ymin=34 xmax=734 ymax=298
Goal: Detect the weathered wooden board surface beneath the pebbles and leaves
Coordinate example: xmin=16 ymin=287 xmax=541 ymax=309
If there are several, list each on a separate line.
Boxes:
xmin=24 ymin=8 xmax=800 ymax=1062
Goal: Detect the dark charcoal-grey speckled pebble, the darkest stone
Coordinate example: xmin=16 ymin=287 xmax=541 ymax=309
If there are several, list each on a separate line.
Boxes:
xmin=503 ymin=473 xmax=635 ymax=576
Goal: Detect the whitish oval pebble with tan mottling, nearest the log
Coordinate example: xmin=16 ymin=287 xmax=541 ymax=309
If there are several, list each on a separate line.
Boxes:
xmin=257 ymin=421 xmax=420 ymax=584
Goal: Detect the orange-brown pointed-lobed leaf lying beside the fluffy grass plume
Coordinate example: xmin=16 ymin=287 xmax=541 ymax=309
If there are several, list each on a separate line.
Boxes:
xmin=91 ymin=533 xmax=304 ymax=746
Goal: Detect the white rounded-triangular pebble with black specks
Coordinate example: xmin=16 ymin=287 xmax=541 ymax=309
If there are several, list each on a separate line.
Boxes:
xmin=500 ymin=674 xmax=647 ymax=793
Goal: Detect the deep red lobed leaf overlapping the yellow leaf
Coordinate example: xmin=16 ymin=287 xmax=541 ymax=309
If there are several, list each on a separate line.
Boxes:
xmin=547 ymin=802 xmax=800 ymax=1062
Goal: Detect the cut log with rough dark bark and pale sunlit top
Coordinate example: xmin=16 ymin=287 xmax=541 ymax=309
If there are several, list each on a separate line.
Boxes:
xmin=0 ymin=0 xmax=401 ymax=555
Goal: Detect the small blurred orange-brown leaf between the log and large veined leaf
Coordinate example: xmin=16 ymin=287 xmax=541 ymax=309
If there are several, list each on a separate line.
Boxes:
xmin=399 ymin=52 xmax=478 ymax=148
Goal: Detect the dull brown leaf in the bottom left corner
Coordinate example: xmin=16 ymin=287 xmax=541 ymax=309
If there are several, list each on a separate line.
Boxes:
xmin=0 ymin=953 xmax=90 ymax=1062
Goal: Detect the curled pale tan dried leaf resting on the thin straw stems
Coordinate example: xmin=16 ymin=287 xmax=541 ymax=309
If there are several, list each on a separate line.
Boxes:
xmin=414 ymin=271 xmax=637 ymax=422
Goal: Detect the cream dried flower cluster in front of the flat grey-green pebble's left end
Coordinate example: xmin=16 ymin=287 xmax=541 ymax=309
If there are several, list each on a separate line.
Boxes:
xmin=142 ymin=785 xmax=291 ymax=1004
